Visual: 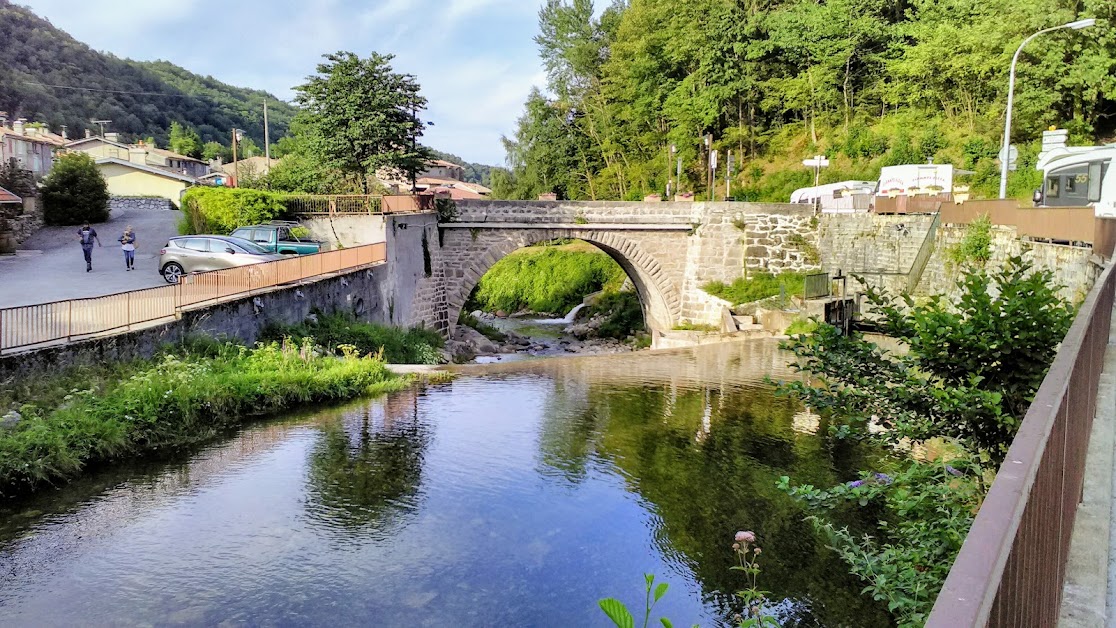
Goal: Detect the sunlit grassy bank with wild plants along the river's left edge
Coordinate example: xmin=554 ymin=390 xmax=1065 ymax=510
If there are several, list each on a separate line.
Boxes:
xmin=0 ymin=340 xmax=408 ymax=495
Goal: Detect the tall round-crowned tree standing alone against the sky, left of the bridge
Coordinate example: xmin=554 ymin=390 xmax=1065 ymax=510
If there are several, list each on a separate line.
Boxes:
xmin=295 ymin=51 xmax=429 ymax=189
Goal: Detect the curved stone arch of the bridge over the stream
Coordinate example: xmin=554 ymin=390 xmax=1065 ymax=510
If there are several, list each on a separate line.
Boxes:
xmin=446 ymin=229 xmax=685 ymax=331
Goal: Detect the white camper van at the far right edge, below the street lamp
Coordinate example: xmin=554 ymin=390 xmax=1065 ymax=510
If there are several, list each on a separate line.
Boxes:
xmin=1035 ymin=144 xmax=1116 ymax=216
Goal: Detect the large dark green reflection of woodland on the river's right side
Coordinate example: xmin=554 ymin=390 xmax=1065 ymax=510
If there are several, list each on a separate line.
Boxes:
xmin=531 ymin=379 xmax=888 ymax=626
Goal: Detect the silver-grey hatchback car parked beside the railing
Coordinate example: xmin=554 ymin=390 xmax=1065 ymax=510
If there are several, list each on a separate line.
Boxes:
xmin=158 ymin=235 xmax=286 ymax=283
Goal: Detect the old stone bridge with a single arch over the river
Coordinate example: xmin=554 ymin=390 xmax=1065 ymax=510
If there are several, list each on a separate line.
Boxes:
xmin=374 ymin=201 xmax=818 ymax=331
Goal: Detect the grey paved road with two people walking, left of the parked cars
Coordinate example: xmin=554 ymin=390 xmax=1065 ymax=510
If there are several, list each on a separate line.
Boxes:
xmin=0 ymin=210 xmax=182 ymax=308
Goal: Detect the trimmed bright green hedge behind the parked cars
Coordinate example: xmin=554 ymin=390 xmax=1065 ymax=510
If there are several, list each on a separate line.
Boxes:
xmin=179 ymin=187 xmax=288 ymax=235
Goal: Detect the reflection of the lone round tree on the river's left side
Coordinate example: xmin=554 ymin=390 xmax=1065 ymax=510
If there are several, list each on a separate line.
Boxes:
xmin=306 ymin=392 xmax=431 ymax=535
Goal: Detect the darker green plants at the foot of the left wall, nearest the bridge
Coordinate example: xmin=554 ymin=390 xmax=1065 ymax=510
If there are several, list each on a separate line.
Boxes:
xmin=261 ymin=312 xmax=445 ymax=365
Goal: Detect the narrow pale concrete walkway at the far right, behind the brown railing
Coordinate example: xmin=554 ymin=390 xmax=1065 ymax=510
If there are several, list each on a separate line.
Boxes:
xmin=1058 ymin=305 xmax=1116 ymax=628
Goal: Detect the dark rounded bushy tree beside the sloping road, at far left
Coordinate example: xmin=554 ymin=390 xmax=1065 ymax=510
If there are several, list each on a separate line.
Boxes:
xmin=42 ymin=153 xmax=108 ymax=224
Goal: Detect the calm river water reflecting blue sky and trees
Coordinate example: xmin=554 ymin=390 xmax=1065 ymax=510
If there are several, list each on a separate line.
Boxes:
xmin=0 ymin=341 xmax=888 ymax=626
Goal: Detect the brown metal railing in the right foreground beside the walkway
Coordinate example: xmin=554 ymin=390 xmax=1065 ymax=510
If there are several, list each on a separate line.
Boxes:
xmin=926 ymin=257 xmax=1116 ymax=628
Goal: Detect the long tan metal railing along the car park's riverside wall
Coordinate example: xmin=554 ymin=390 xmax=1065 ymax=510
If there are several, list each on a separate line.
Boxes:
xmin=0 ymin=242 xmax=387 ymax=355
